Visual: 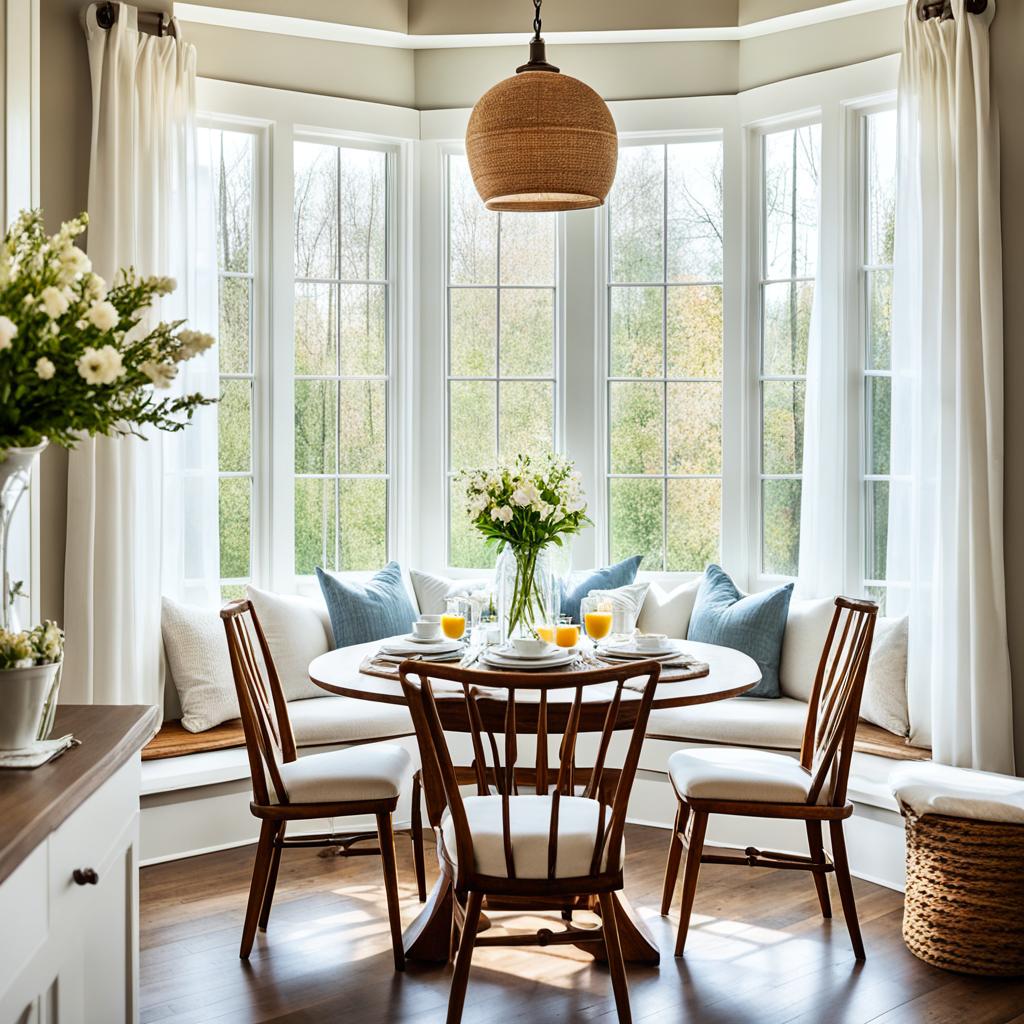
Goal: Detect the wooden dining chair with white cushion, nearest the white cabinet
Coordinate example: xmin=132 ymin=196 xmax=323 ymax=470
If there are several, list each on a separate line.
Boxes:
xmin=220 ymin=600 xmax=423 ymax=971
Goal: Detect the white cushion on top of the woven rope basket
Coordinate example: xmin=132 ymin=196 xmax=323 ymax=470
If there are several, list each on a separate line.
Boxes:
xmin=889 ymin=762 xmax=1024 ymax=825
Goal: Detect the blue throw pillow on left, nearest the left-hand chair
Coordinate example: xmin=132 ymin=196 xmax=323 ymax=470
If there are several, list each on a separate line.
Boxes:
xmin=316 ymin=562 xmax=416 ymax=647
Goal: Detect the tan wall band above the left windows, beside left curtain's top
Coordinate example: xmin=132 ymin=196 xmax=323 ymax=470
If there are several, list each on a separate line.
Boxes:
xmin=183 ymin=23 xmax=416 ymax=106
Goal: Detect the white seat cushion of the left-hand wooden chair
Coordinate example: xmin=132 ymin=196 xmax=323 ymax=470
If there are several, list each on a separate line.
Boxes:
xmin=275 ymin=743 xmax=413 ymax=804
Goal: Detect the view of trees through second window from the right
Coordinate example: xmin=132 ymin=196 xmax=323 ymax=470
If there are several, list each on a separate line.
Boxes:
xmin=759 ymin=124 xmax=821 ymax=577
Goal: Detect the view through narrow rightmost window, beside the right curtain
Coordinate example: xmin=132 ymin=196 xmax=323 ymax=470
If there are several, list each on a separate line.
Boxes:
xmin=860 ymin=110 xmax=896 ymax=609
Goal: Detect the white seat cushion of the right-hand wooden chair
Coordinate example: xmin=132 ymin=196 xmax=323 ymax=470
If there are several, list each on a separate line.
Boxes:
xmin=669 ymin=746 xmax=825 ymax=804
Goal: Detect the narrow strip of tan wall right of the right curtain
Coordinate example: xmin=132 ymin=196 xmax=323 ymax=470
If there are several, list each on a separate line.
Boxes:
xmin=992 ymin=3 xmax=1024 ymax=774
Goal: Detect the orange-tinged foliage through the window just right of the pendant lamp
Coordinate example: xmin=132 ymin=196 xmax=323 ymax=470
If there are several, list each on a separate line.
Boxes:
xmin=607 ymin=140 xmax=724 ymax=571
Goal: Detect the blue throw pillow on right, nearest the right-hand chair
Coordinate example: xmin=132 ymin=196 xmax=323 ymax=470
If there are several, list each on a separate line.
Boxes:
xmin=686 ymin=565 xmax=793 ymax=697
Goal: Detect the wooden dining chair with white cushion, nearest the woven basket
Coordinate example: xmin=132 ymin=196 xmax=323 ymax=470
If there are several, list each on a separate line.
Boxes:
xmin=662 ymin=597 xmax=878 ymax=961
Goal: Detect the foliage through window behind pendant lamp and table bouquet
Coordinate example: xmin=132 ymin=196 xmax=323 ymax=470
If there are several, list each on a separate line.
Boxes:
xmin=445 ymin=155 xmax=557 ymax=567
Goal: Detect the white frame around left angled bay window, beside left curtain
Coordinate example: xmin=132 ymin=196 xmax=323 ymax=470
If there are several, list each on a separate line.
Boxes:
xmin=198 ymin=79 xmax=419 ymax=593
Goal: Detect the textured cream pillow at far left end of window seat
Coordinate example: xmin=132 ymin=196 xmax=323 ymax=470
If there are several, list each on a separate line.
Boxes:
xmin=161 ymin=597 xmax=239 ymax=732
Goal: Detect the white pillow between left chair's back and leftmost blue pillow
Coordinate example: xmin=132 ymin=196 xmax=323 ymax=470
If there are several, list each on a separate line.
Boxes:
xmin=246 ymin=587 xmax=334 ymax=700
